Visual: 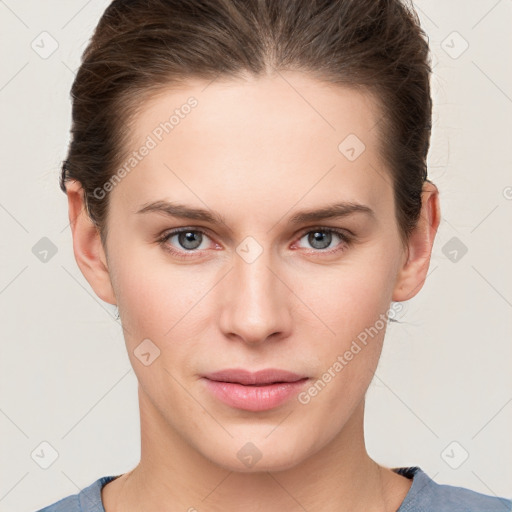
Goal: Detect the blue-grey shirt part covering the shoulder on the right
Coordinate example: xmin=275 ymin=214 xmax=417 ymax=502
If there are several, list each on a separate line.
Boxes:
xmin=393 ymin=466 xmax=512 ymax=512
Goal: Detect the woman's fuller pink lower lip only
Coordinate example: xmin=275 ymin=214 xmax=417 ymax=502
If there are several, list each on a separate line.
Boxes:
xmin=203 ymin=378 xmax=309 ymax=411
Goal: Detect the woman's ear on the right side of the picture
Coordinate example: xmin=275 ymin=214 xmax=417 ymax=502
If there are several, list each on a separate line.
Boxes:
xmin=392 ymin=181 xmax=441 ymax=302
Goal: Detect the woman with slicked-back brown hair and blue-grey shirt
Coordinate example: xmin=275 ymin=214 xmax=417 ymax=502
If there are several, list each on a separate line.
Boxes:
xmin=36 ymin=0 xmax=512 ymax=512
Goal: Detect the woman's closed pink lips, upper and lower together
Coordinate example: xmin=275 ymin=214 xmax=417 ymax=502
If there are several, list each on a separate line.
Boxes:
xmin=202 ymin=368 xmax=309 ymax=412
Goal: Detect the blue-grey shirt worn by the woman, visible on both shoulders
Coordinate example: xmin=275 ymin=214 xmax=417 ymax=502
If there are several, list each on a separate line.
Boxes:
xmin=37 ymin=466 xmax=512 ymax=512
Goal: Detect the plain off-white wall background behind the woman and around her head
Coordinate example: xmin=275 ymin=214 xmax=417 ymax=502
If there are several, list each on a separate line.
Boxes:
xmin=0 ymin=0 xmax=512 ymax=512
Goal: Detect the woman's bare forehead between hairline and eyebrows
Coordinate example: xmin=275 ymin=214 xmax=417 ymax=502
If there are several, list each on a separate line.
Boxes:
xmin=113 ymin=73 xmax=391 ymax=218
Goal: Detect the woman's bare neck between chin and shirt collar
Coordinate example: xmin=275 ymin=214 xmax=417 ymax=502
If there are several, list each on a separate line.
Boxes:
xmin=102 ymin=387 xmax=410 ymax=512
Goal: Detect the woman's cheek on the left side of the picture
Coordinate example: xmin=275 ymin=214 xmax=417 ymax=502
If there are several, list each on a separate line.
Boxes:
xmin=113 ymin=258 xmax=209 ymax=396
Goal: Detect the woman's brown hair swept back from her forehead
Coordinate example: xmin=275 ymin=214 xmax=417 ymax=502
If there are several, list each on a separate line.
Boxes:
xmin=60 ymin=0 xmax=432 ymax=248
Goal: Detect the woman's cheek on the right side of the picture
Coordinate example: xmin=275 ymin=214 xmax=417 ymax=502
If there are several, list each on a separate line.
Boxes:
xmin=292 ymin=261 xmax=391 ymax=400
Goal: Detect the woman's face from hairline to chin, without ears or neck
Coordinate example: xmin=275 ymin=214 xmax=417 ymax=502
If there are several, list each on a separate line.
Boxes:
xmin=99 ymin=73 xmax=404 ymax=471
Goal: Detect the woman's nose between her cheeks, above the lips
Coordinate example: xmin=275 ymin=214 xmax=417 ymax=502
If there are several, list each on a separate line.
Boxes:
xmin=219 ymin=246 xmax=293 ymax=345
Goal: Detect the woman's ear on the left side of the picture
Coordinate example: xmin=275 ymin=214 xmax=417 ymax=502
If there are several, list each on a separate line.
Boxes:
xmin=66 ymin=180 xmax=117 ymax=305
